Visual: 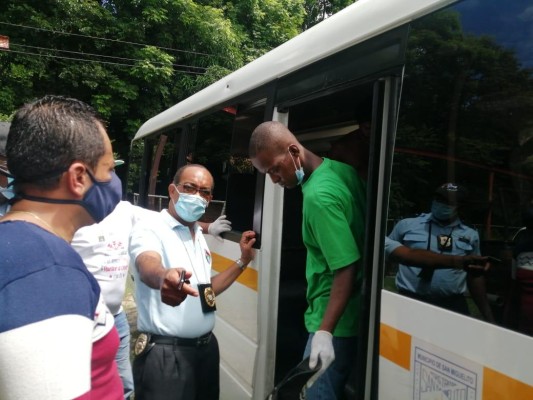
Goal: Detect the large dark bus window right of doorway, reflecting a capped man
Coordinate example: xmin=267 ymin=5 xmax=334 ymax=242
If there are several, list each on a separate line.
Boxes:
xmin=385 ymin=1 xmax=533 ymax=323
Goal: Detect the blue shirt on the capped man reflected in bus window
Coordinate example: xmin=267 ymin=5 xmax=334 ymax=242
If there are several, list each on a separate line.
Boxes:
xmin=389 ymin=213 xmax=480 ymax=298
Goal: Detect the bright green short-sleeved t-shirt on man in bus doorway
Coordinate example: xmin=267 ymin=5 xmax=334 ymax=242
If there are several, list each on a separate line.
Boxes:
xmin=302 ymin=158 xmax=366 ymax=337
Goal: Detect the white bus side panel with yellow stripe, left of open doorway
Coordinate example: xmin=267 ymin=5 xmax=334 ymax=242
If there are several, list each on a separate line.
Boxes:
xmin=206 ymin=180 xmax=283 ymax=400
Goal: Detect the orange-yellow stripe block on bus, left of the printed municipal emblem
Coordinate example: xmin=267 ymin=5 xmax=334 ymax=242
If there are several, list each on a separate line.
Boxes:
xmin=379 ymin=323 xmax=411 ymax=371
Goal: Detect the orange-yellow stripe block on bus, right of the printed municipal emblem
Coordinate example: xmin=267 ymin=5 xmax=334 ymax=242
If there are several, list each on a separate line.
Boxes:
xmin=483 ymin=367 xmax=533 ymax=400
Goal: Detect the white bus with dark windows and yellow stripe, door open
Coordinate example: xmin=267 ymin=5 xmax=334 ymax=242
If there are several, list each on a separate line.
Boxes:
xmin=134 ymin=0 xmax=533 ymax=400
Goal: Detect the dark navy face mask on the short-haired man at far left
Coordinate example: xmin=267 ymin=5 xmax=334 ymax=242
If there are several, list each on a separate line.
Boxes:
xmin=17 ymin=170 xmax=122 ymax=222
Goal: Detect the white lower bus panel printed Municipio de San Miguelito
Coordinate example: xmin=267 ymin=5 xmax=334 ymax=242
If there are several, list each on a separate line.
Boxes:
xmin=379 ymin=291 xmax=533 ymax=400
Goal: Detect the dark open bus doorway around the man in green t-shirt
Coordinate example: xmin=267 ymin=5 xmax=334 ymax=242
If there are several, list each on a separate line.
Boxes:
xmin=267 ymin=70 xmax=401 ymax=399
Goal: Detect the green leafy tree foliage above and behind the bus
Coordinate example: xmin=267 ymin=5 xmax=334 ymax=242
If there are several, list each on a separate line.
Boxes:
xmin=0 ymin=0 xmax=332 ymax=178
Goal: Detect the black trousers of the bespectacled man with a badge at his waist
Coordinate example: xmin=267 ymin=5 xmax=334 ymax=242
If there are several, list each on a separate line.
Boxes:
xmin=133 ymin=335 xmax=220 ymax=400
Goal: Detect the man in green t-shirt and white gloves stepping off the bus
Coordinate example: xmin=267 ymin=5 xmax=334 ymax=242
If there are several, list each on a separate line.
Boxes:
xmin=249 ymin=121 xmax=366 ymax=400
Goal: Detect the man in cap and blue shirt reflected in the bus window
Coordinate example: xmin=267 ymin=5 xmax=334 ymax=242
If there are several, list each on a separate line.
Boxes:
xmin=389 ymin=183 xmax=494 ymax=321
